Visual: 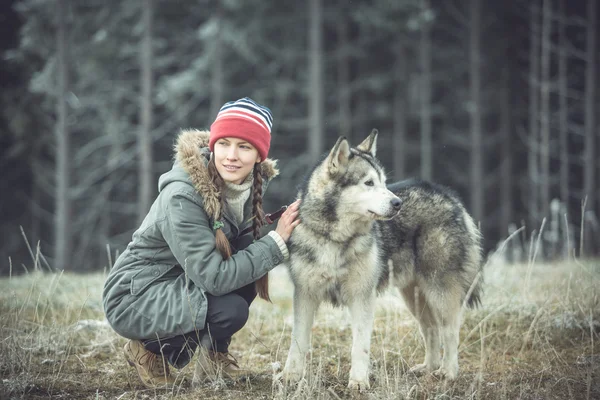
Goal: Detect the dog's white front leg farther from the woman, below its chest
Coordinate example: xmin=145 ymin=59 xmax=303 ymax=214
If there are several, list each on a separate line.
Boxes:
xmin=348 ymin=293 xmax=375 ymax=391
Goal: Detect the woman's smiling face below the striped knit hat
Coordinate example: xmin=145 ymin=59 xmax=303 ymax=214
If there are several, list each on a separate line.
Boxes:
xmin=213 ymin=137 xmax=261 ymax=185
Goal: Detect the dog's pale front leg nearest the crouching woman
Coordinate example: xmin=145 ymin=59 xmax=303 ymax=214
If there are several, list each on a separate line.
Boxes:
xmin=283 ymin=289 xmax=318 ymax=382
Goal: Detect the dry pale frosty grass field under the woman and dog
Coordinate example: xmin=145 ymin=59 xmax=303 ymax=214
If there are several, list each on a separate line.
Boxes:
xmin=0 ymin=261 xmax=600 ymax=399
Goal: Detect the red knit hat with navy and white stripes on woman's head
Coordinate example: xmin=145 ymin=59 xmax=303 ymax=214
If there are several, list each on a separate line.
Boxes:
xmin=208 ymin=97 xmax=273 ymax=160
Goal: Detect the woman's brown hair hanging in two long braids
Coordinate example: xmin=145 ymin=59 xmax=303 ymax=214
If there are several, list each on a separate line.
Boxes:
xmin=208 ymin=156 xmax=271 ymax=301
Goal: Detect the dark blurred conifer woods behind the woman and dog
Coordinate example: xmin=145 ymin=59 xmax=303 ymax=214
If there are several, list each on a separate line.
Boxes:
xmin=0 ymin=0 xmax=600 ymax=273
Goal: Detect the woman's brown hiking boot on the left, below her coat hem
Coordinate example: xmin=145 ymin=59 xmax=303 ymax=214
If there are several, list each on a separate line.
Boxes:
xmin=123 ymin=340 xmax=175 ymax=389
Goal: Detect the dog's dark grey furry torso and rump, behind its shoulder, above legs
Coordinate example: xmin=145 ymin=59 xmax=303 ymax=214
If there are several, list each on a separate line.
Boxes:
xmin=380 ymin=179 xmax=482 ymax=306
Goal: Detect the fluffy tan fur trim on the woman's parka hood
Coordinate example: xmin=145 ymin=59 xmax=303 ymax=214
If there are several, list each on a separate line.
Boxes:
xmin=158 ymin=129 xmax=279 ymax=219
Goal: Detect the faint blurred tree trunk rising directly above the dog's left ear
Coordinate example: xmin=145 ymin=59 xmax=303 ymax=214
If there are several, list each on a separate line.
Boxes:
xmin=336 ymin=9 xmax=352 ymax=143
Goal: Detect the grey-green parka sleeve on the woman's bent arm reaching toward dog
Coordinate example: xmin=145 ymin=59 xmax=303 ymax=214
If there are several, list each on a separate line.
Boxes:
xmin=163 ymin=193 xmax=284 ymax=296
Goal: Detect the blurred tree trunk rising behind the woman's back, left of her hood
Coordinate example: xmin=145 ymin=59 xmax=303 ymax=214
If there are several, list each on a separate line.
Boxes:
xmin=138 ymin=0 xmax=154 ymax=222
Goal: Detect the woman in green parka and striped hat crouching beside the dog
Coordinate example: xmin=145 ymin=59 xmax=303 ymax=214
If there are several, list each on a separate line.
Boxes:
xmin=103 ymin=98 xmax=300 ymax=388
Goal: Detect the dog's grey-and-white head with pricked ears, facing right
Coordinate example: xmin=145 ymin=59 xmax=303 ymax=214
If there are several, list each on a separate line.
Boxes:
xmin=308 ymin=129 xmax=402 ymax=220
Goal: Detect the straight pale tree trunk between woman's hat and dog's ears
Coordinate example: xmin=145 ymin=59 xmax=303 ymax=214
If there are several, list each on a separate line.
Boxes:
xmin=308 ymin=0 xmax=324 ymax=163
